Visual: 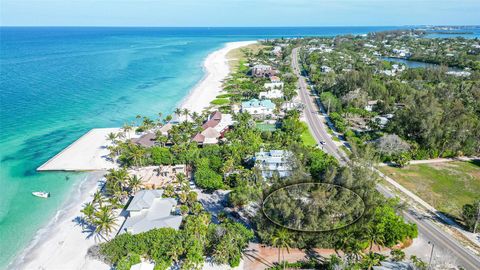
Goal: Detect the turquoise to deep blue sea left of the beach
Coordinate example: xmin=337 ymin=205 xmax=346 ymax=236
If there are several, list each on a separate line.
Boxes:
xmin=0 ymin=27 xmax=402 ymax=269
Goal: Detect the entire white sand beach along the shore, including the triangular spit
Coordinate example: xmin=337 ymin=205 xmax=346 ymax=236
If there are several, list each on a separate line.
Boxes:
xmin=10 ymin=41 xmax=255 ymax=270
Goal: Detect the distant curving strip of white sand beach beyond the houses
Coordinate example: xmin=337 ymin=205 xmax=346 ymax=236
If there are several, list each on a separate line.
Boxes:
xmin=180 ymin=41 xmax=256 ymax=113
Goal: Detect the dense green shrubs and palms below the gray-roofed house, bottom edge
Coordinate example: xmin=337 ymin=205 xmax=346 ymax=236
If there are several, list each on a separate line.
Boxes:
xmin=100 ymin=214 xmax=253 ymax=269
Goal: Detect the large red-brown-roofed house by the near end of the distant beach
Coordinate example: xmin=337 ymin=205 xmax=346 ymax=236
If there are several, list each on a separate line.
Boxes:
xmin=192 ymin=111 xmax=234 ymax=145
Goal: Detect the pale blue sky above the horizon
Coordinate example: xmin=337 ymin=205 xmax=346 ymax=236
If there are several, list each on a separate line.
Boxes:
xmin=0 ymin=0 xmax=480 ymax=27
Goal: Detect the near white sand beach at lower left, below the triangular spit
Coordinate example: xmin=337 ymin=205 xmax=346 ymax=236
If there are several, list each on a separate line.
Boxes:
xmin=7 ymin=171 xmax=109 ymax=269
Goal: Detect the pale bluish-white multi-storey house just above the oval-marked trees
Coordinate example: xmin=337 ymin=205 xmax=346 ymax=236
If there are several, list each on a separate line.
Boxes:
xmin=253 ymin=150 xmax=292 ymax=179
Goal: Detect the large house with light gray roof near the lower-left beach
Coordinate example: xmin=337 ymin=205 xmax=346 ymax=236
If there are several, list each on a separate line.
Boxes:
xmin=119 ymin=190 xmax=182 ymax=234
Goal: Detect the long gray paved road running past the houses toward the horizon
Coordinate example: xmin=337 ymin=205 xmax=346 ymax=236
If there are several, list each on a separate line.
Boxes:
xmin=292 ymin=48 xmax=480 ymax=270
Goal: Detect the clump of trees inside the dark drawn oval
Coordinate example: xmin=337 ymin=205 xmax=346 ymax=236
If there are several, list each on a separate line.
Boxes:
xmin=263 ymin=183 xmax=365 ymax=232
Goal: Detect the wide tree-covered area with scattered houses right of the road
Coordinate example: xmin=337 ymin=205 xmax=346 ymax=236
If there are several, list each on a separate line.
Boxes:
xmin=301 ymin=31 xmax=480 ymax=161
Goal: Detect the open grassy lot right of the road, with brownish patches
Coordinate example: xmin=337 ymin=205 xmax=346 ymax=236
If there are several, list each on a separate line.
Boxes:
xmin=379 ymin=161 xmax=480 ymax=219
